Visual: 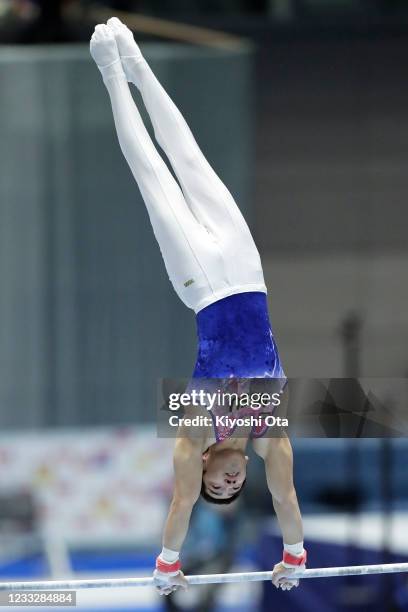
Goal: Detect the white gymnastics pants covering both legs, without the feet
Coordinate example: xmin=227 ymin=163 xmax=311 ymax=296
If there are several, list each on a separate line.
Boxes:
xmin=105 ymin=58 xmax=266 ymax=312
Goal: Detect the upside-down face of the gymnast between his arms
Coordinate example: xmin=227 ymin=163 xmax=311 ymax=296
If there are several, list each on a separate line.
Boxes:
xmin=203 ymin=448 xmax=248 ymax=499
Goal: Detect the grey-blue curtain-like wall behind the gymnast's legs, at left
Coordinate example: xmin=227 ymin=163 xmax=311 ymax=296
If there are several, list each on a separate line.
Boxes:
xmin=0 ymin=45 xmax=252 ymax=426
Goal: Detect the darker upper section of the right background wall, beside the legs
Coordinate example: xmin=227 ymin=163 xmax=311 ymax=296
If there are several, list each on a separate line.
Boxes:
xmin=256 ymin=35 xmax=408 ymax=252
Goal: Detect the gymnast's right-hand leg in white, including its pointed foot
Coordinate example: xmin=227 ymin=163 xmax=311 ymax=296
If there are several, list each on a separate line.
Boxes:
xmin=108 ymin=17 xmax=266 ymax=291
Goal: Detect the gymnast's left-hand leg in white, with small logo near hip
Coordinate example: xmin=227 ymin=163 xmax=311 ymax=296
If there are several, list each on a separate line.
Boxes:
xmin=91 ymin=25 xmax=226 ymax=308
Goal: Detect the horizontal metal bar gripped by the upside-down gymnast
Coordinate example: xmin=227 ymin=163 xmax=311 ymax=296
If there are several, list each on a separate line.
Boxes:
xmin=0 ymin=563 xmax=408 ymax=591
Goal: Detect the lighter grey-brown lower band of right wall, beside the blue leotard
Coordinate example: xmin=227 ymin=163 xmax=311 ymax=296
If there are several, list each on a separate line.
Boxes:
xmin=264 ymin=253 xmax=408 ymax=378
